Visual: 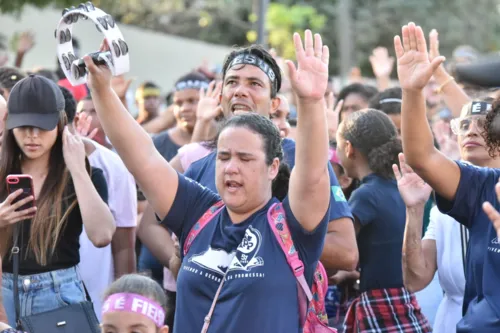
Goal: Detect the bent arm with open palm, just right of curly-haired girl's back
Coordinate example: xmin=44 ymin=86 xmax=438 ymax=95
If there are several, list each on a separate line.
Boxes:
xmin=392 ymin=154 xmax=437 ymax=292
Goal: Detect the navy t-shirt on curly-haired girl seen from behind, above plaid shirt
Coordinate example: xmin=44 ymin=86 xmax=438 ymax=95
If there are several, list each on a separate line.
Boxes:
xmin=349 ymin=174 xmax=406 ymax=292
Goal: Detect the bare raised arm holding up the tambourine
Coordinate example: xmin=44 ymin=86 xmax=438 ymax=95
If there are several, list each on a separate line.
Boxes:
xmin=84 ymin=43 xmax=179 ymax=219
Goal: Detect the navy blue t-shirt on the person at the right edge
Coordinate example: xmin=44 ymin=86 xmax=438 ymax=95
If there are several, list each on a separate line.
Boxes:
xmin=436 ymin=162 xmax=500 ymax=333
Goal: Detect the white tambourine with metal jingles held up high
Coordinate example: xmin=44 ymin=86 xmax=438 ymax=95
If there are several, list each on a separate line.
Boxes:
xmin=54 ymin=1 xmax=130 ymax=86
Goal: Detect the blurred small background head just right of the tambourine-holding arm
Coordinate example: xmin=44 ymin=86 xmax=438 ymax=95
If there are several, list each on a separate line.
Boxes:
xmin=135 ymin=82 xmax=161 ymax=125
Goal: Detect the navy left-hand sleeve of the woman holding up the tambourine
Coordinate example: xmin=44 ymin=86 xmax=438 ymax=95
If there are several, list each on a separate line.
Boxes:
xmin=161 ymin=174 xmax=220 ymax=240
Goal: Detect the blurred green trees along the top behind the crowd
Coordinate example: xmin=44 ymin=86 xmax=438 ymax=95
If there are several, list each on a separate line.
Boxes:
xmin=0 ymin=0 xmax=500 ymax=75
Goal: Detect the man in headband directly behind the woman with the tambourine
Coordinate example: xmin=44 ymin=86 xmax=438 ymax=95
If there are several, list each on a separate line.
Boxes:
xmin=185 ymin=45 xmax=358 ymax=274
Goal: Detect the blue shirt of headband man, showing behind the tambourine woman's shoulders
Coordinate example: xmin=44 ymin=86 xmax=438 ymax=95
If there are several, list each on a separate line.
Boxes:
xmin=184 ymin=138 xmax=352 ymax=221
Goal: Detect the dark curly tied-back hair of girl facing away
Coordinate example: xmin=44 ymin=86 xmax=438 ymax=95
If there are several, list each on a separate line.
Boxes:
xmin=339 ymin=109 xmax=403 ymax=179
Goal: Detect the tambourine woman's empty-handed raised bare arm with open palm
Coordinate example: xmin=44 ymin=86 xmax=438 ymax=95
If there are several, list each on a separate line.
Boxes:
xmin=287 ymin=30 xmax=330 ymax=231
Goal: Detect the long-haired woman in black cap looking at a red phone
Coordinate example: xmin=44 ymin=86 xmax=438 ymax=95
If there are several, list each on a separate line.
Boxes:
xmin=0 ymin=75 xmax=115 ymax=326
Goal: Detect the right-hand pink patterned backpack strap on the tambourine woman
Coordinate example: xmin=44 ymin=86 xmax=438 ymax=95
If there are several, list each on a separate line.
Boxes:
xmin=267 ymin=202 xmax=313 ymax=324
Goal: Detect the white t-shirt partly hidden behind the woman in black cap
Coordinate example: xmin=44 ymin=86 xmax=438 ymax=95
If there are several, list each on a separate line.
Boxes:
xmin=79 ymin=141 xmax=137 ymax=320
